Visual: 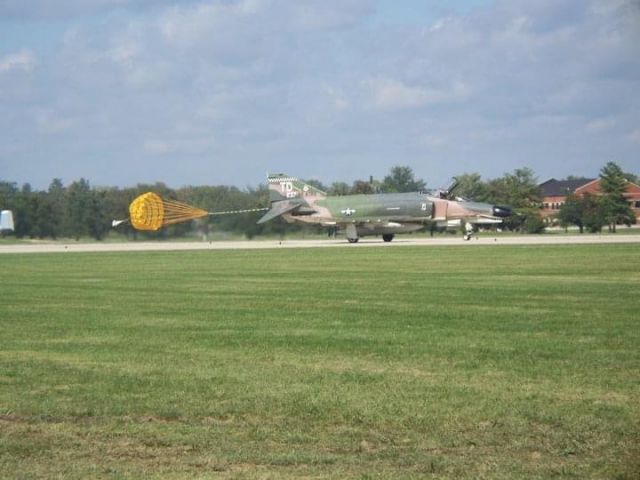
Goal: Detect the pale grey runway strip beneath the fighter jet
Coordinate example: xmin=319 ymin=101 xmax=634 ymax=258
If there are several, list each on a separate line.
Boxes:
xmin=0 ymin=234 xmax=640 ymax=254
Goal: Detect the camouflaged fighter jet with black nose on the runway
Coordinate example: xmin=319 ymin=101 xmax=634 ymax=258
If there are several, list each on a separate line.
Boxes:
xmin=258 ymin=173 xmax=511 ymax=243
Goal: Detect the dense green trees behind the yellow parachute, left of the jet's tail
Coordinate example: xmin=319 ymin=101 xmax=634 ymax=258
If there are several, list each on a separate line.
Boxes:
xmin=0 ymin=178 xmax=281 ymax=240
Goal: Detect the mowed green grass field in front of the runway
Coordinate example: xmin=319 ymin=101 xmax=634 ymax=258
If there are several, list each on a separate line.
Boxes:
xmin=0 ymin=245 xmax=640 ymax=479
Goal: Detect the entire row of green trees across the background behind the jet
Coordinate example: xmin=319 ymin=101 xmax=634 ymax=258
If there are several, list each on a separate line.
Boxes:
xmin=0 ymin=162 xmax=637 ymax=240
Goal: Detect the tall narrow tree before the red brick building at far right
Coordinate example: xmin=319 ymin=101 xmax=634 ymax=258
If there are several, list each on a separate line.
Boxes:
xmin=600 ymin=162 xmax=635 ymax=233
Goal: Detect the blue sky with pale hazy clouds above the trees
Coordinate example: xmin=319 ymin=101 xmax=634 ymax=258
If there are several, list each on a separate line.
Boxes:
xmin=0 ymin=0 xmax=640 ymax=189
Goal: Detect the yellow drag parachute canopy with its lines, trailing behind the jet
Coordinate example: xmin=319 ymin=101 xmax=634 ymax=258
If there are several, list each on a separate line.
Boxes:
xmin=129 ymin=192 xmax=209 ymax=230
